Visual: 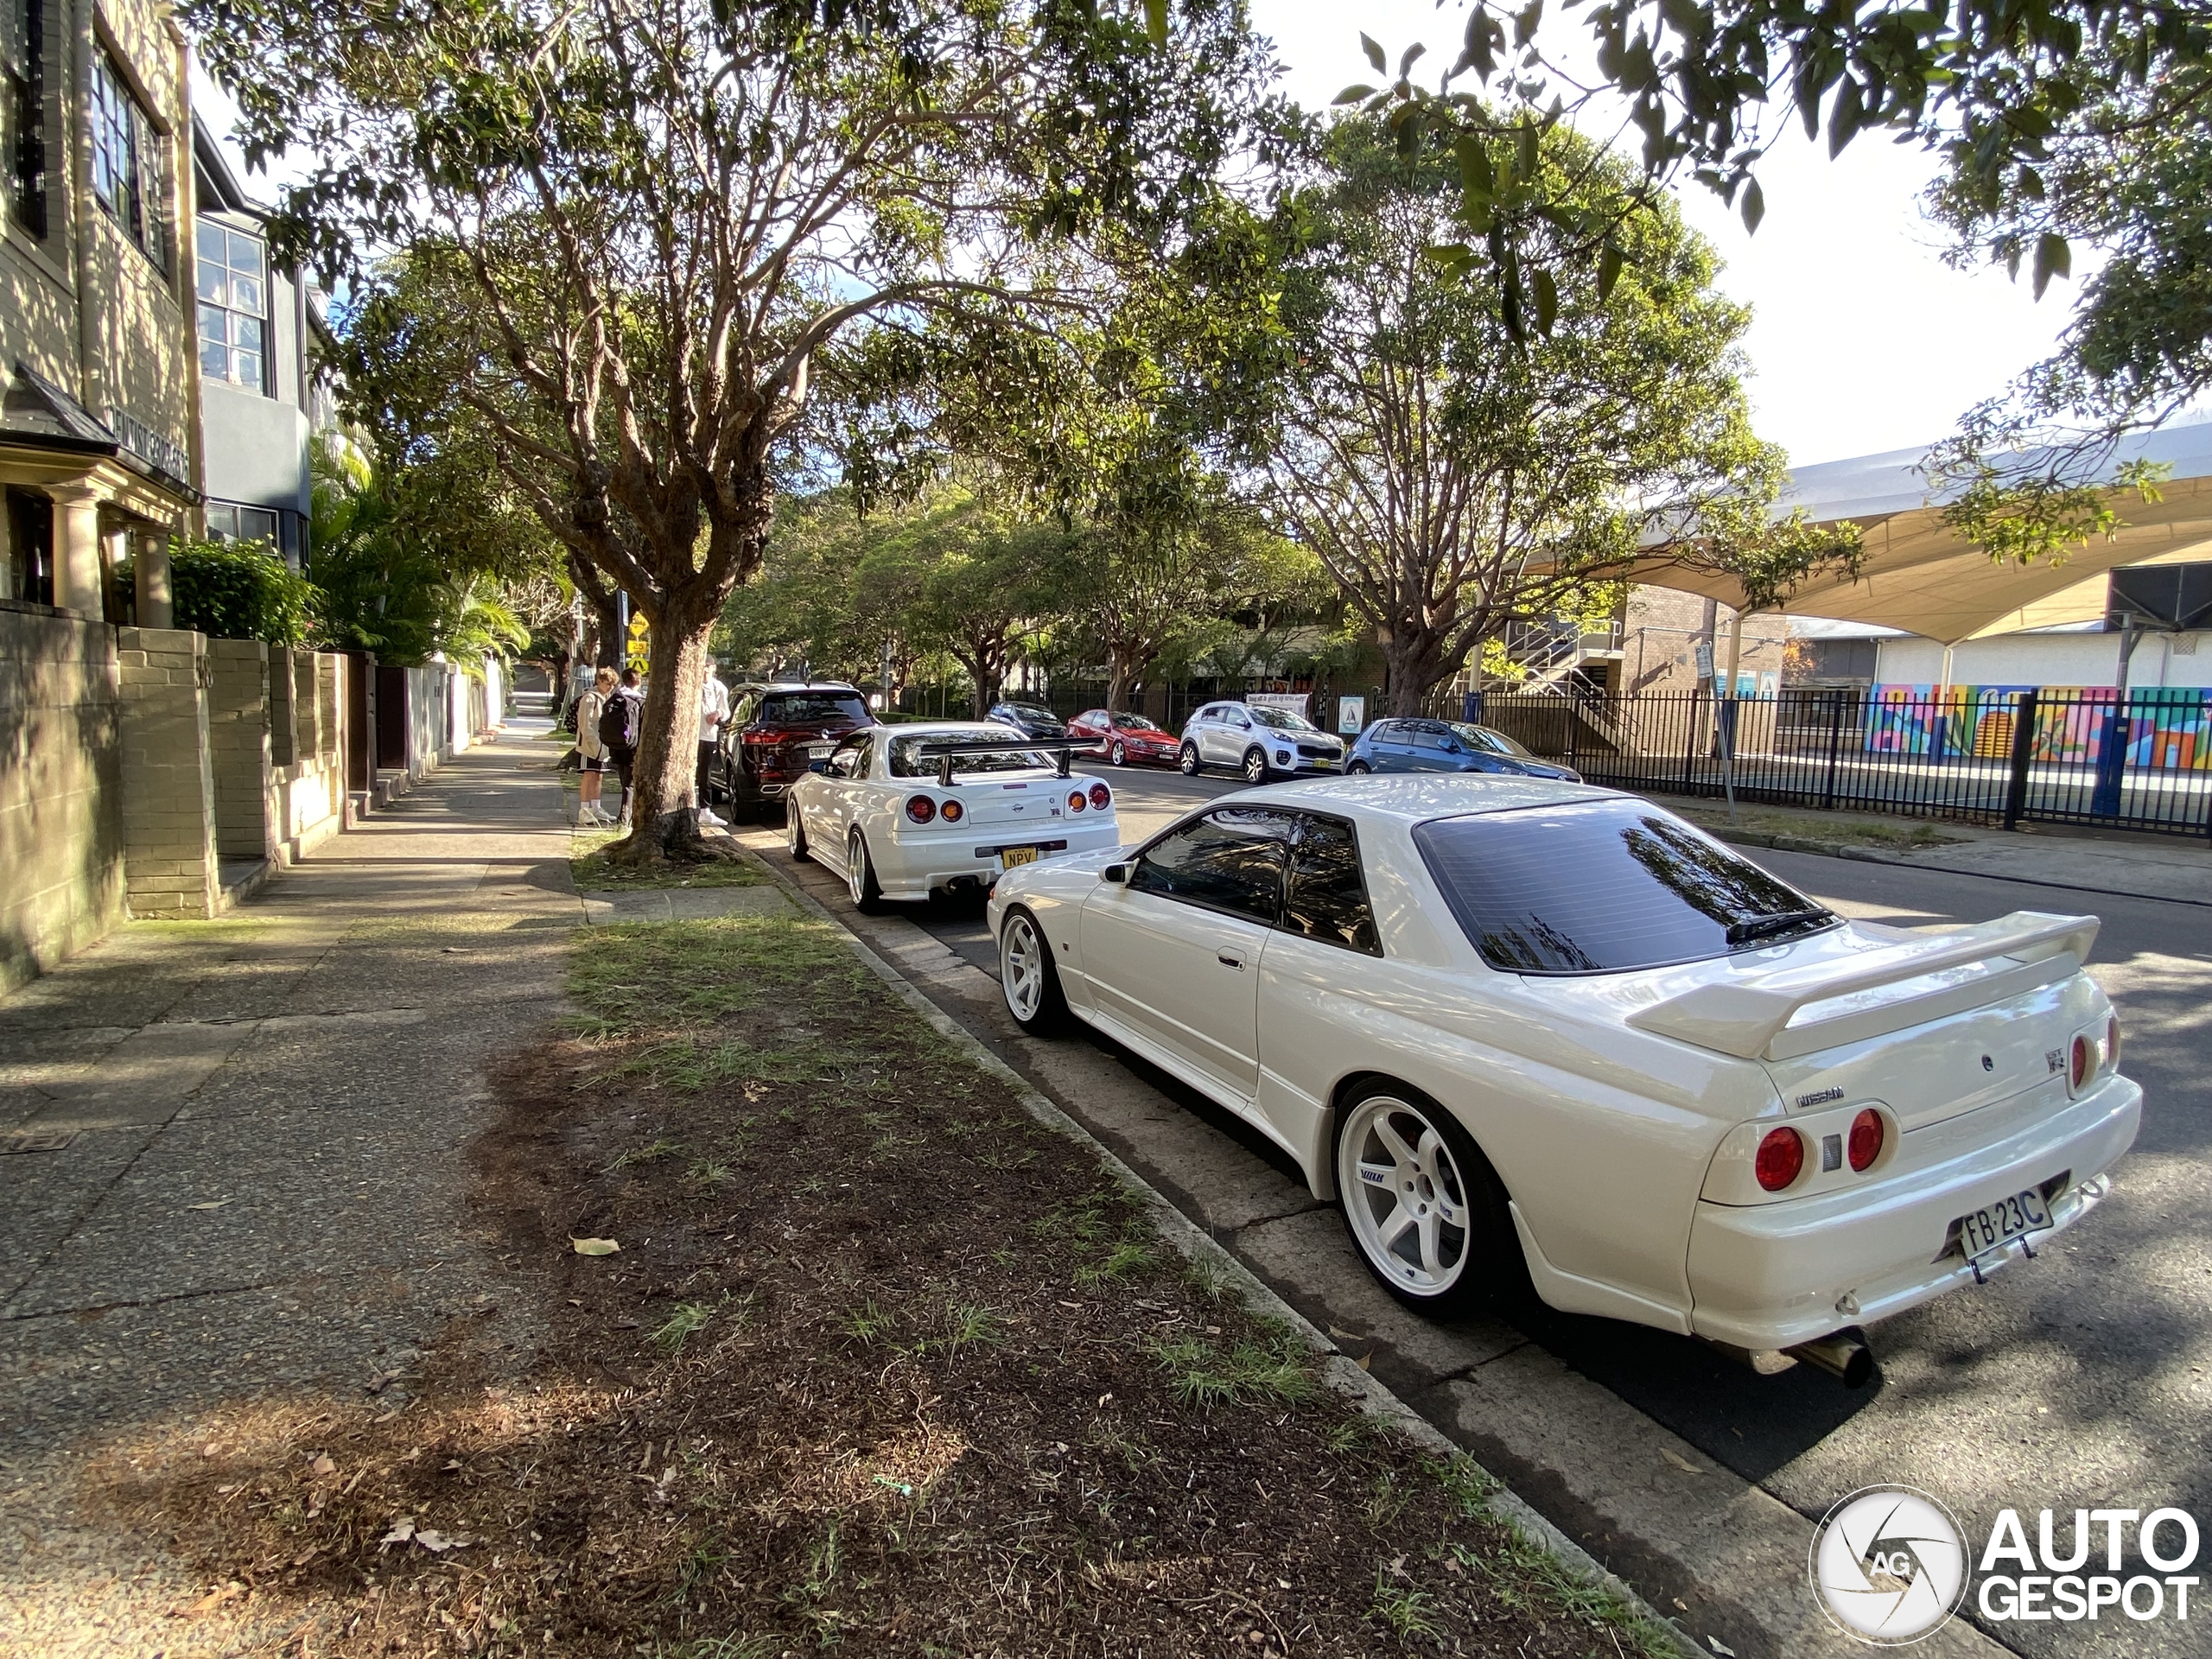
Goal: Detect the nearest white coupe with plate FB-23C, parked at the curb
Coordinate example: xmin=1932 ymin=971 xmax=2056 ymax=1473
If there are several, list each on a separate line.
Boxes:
xmin=991 ymin=777 xmax=2141 ymax=1382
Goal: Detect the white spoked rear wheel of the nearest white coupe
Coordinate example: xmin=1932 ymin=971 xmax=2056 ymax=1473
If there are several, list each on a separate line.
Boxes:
xmin=1336 ymin=1095 xmax=1473 ymax=1300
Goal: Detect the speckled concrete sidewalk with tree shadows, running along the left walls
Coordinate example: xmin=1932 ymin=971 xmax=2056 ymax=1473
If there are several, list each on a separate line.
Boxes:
xmin=0 ymin=732 xmax=584 ymax=1659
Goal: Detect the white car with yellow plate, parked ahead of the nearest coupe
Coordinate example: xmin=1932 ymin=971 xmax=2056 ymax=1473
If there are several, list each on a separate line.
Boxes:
xmin=785 ymin=721 xmax=1122 ymax=912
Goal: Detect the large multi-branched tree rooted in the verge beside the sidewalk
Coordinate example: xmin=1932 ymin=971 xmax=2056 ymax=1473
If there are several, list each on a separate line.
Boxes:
xmin=190 ymin=0 xmax=1292 ymax=858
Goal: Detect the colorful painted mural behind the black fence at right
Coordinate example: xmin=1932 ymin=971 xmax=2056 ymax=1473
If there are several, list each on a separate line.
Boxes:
xmin=1867 ymin=686 xmax=2212 ymax=772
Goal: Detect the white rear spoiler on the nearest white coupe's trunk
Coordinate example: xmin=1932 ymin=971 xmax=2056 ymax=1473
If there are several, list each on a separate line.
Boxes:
xmin=1628 ymin=909 xmax=2099 ymax=1059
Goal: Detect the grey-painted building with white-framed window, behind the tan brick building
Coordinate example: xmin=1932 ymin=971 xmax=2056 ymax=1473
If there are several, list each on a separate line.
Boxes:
xmin=193 ymin=118 xmax=332 ymax=569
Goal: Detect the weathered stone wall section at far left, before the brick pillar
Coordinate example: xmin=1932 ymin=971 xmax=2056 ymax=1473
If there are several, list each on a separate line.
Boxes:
xmin=0 ymin=608 xmax=124 ymax=993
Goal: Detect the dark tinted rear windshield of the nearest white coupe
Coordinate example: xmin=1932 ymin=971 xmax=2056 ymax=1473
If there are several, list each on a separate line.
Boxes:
xmin=1414 ymin=801 xmax=1838 ymax=973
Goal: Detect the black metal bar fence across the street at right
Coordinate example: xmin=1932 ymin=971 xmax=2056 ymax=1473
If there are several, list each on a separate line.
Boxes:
xmin=1455 ymin=688 xmax=2212 ymax=836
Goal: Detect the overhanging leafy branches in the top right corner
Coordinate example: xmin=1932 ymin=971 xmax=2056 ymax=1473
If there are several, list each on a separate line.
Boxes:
xmin=1340 ymin=0 xmax=2212 ymax=542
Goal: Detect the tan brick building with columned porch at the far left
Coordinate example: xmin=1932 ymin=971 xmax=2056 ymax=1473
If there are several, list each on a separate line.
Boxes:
xmin=0 ymin=0 xmax=199 ymax=626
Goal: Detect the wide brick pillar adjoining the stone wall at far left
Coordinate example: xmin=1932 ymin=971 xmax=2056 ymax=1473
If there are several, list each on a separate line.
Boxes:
xmin=118 ymin=628 xmax=221 ymax=918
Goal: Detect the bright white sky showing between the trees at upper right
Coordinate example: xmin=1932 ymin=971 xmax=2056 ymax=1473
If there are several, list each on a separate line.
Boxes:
xmin=1252 ymin=0 xmax=2073 ymax=465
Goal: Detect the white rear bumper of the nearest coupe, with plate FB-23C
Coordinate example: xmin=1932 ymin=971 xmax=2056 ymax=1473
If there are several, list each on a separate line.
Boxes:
xmin=1690 ymin=1077 xmax=2144 ymax=1350
